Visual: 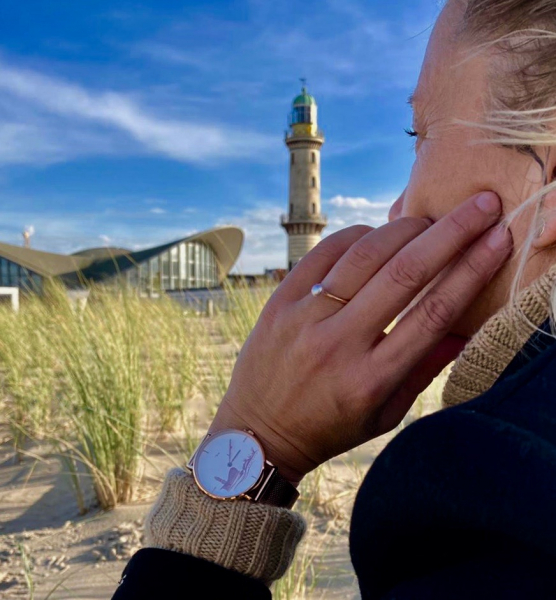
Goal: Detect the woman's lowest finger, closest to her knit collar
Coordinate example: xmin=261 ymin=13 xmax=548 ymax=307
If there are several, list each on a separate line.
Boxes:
xmin=369 ymin=220 xmax=512 ymax=395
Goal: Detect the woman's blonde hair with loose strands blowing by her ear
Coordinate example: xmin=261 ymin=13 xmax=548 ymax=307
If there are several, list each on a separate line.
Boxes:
xmin=460 ymin=0 xmax=556 ymax=322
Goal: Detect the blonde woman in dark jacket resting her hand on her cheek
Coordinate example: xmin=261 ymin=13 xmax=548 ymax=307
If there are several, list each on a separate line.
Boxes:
xmin=114 ymin=0 xmax=556 ymax=600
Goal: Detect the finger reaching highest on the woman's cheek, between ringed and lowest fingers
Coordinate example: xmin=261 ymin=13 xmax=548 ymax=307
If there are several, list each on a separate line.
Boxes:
xmin=334 ymin=192 xmax=501 ymax=343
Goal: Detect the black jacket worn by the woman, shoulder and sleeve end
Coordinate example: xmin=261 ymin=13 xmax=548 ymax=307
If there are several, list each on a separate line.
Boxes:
xmin=113 ymin=326 xmax=556 ymax=600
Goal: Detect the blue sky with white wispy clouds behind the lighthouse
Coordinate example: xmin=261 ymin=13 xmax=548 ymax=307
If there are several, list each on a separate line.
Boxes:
xmin=0 ymin=0 xmax=439 ymax=272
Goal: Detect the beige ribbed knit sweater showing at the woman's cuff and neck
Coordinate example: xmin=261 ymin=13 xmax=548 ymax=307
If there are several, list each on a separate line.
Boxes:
xmin=146 ymin=267 xmax=556 ymax=585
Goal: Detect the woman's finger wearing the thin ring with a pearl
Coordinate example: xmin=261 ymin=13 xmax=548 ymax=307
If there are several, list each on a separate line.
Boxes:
xmin=302 ymin=218 xmax=432 ymax=322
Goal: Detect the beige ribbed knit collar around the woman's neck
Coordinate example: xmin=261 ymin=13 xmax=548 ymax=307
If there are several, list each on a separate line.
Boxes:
xmin=442 ymin=266 xmax=556 ymax=406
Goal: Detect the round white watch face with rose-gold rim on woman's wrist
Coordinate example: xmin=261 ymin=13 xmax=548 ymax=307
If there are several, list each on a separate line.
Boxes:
xmin=193 ymin=430 xmax=265 ymax=498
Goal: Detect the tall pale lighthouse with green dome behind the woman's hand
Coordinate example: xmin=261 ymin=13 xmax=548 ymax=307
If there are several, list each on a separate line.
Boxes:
xmin=281 ymin=85 xmax=327 ymax=270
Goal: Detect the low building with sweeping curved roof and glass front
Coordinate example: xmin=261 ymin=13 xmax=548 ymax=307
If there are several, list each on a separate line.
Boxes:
xmin=0 ymin=227 xmax=243 ymax=295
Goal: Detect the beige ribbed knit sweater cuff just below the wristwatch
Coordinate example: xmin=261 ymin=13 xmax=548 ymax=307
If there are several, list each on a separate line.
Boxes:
xmin=145 ymin=469 xmax=305 ymax=585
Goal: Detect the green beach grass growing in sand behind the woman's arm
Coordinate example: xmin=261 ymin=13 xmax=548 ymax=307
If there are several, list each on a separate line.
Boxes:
xmin=0 ymin=284 xmax=445 ymax=600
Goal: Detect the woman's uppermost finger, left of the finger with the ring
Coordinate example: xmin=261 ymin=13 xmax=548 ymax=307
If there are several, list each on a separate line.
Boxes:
xmin=275 ymin=225 xmax=373 ymax=301
